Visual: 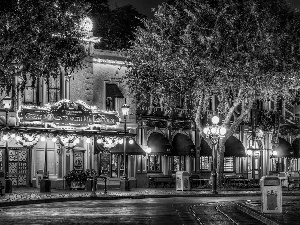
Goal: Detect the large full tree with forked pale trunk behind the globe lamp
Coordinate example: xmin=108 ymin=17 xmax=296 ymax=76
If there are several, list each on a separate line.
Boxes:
xmin=124 ymin=0 xmax=300 ymax=181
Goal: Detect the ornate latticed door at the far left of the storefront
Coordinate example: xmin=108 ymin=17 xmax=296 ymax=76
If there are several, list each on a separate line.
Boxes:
xmin=8 ymin=148 xmax=28 ymax=186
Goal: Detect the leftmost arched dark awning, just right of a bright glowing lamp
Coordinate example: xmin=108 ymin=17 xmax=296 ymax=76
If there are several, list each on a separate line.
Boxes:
xmin=147 ymin=132 xmax=172 ymax=155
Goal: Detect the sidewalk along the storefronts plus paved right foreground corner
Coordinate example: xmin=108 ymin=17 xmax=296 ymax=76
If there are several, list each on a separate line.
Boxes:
xmin=0 ymin=188 xmax=300 ymax=224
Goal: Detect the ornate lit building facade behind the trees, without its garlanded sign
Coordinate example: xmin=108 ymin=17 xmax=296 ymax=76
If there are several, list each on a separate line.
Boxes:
xmin=0 ymin=49 xmax=300 ymax=189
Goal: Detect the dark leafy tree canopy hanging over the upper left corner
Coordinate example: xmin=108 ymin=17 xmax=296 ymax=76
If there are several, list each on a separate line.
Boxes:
xmin=0 ymin=0 xmax=89 ymax=93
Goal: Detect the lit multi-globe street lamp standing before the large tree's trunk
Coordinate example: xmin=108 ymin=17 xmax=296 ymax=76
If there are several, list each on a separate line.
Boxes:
xmin=203 ymin=116 xmax=227 ymax=194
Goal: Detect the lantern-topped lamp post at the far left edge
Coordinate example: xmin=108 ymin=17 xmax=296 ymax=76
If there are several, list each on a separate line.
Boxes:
xmin=2 ymin=97 xmax=12 ymax=193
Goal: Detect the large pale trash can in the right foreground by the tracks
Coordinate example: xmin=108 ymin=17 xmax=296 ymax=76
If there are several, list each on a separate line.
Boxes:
xmin=260 ymin=176 xmax=282 ymax=213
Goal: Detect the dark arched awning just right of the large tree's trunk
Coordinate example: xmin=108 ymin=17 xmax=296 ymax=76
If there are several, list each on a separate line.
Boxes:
xmin=224 ymin=136 xmax=246 ymax=157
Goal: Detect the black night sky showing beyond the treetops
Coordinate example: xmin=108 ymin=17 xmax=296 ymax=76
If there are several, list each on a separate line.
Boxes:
xmin=109 ymin=0 xmax=300 ymax=18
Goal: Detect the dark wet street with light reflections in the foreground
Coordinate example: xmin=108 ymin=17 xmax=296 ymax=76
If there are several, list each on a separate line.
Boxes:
xmin=0 ymin=196 xmax=272 ymax=225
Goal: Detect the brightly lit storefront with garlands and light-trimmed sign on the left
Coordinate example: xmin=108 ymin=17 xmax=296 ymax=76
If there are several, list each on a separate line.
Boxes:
xmin=0 ymin=100 xmax=141 ymax=189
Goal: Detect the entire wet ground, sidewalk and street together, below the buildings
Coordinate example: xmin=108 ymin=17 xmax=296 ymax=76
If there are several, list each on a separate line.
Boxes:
xmin=0 ymin=188 xmax=300 ymax=225
